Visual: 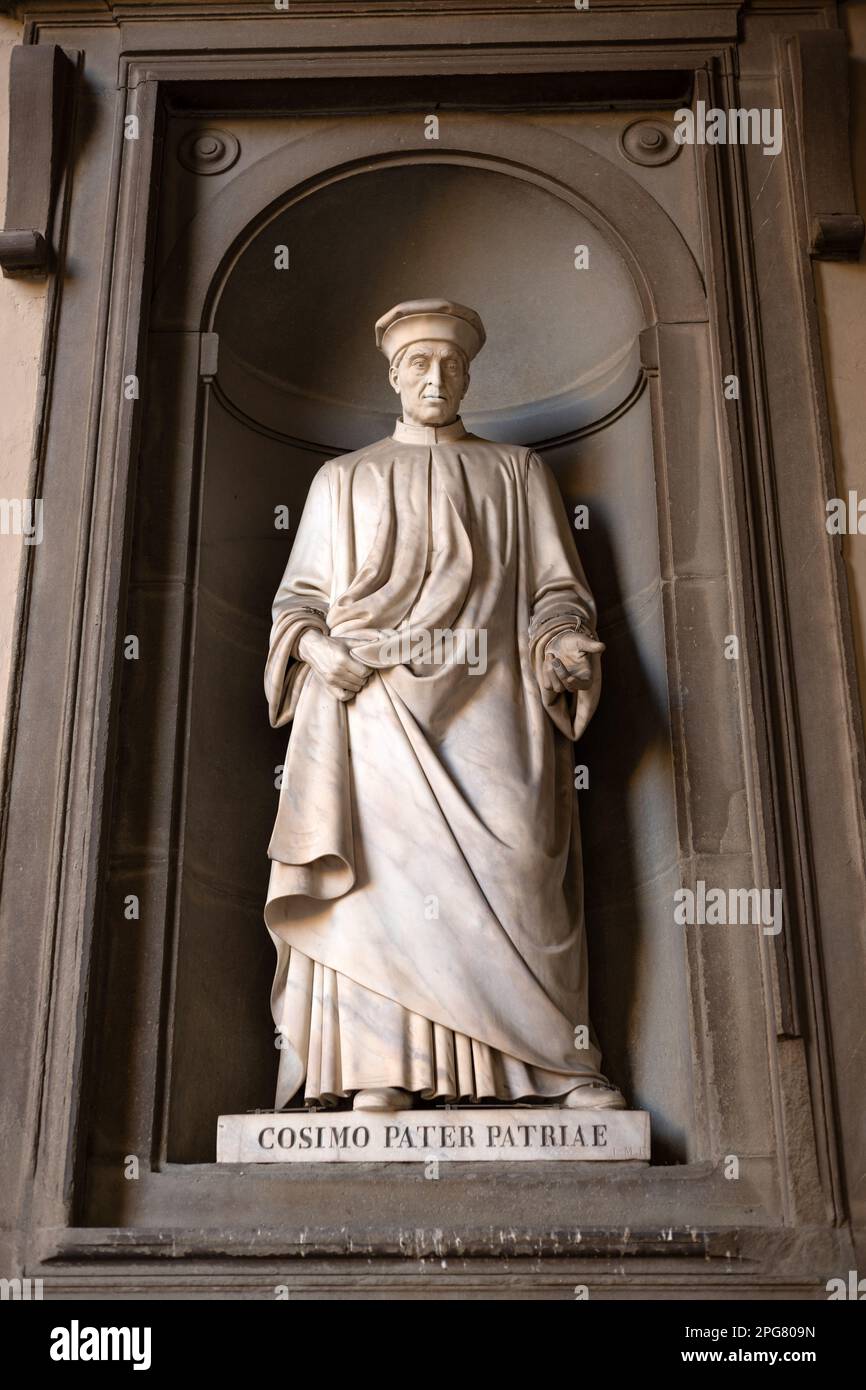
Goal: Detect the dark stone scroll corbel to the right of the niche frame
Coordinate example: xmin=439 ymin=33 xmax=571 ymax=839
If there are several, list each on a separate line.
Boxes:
xmin=787 ymin=29 xmax=865 ymax=260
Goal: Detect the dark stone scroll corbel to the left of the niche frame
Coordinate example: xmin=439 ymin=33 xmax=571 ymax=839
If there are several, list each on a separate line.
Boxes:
xmin=0 ymin=43 xmax=75 ymax=275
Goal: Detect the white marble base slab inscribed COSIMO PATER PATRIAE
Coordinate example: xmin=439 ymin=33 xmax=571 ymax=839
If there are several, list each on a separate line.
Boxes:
xmin=217 ymin=1106 xmax=649 ymax=1163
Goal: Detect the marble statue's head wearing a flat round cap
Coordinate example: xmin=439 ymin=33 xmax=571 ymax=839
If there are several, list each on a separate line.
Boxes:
xmin=375 ymin=299 xmax=485 ymax=425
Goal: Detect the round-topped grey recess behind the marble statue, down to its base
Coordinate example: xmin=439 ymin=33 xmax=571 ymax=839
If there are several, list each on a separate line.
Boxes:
xmin=155 ymin=158 xmax=694 ymax=1162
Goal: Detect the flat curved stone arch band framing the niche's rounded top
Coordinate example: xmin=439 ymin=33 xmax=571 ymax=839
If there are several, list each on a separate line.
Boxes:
xmin=152 ymin=114 xmax=708 ymax=332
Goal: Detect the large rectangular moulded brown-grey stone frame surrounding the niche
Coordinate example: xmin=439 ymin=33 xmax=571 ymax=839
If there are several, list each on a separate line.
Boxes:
xmin=0 ymin=3 xmax=866 ymax=1297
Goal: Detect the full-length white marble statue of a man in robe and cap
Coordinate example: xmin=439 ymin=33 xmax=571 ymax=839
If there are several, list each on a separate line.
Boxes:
xmin=265 ymin=300 xmax=626 ymax=1111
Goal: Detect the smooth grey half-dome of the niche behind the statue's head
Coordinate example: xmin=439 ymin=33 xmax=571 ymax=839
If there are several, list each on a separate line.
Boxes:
xmin=214 ymin=161 xmax=644 ymax=435
